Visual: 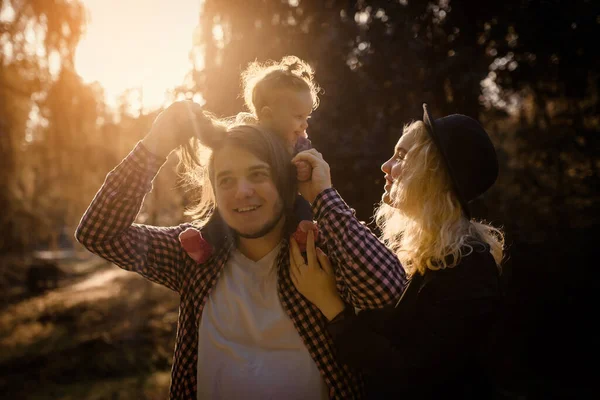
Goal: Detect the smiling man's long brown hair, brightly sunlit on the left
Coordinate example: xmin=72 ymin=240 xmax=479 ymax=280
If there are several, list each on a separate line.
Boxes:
xmin=179 ymin=119 xmax=297 ymax=233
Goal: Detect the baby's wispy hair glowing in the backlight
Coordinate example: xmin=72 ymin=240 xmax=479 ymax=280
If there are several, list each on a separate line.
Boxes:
xmin=242 ymin=56 xmax=321 ymax=118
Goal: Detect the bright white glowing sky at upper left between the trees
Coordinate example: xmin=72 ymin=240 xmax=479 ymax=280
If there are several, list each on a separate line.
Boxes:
xmin=75 ymin=0 xmax=202 ymax=110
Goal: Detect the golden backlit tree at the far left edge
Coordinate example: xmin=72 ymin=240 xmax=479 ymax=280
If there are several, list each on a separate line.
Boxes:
xmin=0 ymin=0 xmax=84 ymax=251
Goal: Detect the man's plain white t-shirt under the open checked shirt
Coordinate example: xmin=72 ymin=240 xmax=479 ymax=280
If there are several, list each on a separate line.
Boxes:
xmin=198 ymin=246 xmax=328 ymax=400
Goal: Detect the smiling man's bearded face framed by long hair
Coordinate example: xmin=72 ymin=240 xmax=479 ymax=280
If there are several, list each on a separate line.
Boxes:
xmin=213 ymin=146 xmax=283 ymax=239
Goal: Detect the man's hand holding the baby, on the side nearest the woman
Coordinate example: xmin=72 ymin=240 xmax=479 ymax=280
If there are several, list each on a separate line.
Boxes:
xmin=292 ymin=149 xmax=331 ymax=204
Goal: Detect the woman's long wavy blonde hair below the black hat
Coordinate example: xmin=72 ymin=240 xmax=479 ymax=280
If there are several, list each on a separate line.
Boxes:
xmin=375 ymin=121 xmax=504 ymax=274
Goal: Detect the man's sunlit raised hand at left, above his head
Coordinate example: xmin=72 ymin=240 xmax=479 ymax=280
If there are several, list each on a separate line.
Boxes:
xmin=142 ymin=100 xmax=207 ymax=158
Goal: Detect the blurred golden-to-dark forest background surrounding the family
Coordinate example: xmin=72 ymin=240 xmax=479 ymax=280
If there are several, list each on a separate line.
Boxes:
xmin=0 ymin=0 xmax=600 ymax=399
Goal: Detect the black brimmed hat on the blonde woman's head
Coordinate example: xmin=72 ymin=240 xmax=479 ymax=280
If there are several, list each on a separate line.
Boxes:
xmin=423 ymin=103 xmax=498 ymax=218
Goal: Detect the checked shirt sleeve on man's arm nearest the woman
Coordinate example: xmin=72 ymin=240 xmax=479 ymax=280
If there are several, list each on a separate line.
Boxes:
xmin=312 ymin=188 xmax=406 ymax=309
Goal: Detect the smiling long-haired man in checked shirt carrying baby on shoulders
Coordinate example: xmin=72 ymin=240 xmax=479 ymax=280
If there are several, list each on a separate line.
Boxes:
xmin=76 ymin=102 xmax=405 ymax=399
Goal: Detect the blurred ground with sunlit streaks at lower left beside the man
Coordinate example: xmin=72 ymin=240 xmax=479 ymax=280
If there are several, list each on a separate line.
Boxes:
xmin=0 ymin=262 xmax=179 ymax=400
